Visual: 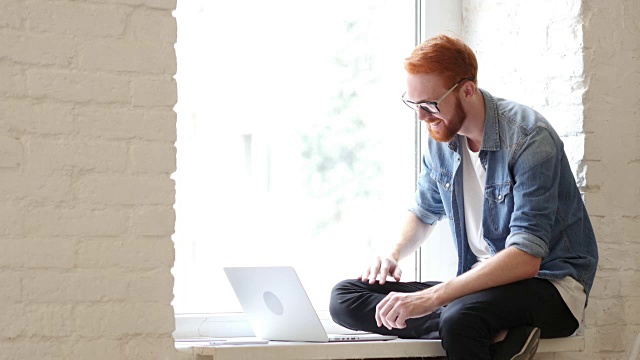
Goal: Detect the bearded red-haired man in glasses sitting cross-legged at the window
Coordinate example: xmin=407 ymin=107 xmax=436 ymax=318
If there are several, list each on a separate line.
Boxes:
xmin=330 ymin=35 xmax=598 ymax=359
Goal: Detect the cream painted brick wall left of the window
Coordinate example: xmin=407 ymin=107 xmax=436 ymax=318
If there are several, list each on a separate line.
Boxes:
xmin=0 ymin=0 xmax=178 ymax=360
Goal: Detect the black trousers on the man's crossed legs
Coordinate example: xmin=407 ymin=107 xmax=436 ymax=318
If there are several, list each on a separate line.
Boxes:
xmin=329 ymin=278 xmax=579 ymax=359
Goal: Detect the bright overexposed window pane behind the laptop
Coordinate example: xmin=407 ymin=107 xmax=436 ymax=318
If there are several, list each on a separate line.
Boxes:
xmin=173 ymin=0 xmax=416 ymax=313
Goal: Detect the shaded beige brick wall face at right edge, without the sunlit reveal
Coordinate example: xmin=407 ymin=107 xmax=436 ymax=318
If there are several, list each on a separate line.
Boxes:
xmin=582 ymin=0 xmax=640 ymax=359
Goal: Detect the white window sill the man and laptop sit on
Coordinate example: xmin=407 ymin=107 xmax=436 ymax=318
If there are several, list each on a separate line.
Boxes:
xmin=176 ymin=336 xmax=585 ymax=360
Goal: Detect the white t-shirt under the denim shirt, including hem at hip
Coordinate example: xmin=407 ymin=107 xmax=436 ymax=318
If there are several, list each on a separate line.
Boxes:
xmin=462 ymin=136 xmax=587 ymax=323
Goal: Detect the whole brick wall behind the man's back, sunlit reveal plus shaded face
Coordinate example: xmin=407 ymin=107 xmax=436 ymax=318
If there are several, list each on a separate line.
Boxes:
xmin=463 ymin=0 xmax=640 ymax=359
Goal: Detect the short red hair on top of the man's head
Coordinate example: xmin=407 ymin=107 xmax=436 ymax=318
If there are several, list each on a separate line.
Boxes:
xmin=404 ymin=34 xmax=478 ymax=86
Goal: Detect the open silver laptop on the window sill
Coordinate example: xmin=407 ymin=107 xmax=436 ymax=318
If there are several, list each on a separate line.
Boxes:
xmin=224 ymin=266 xmax=397 ymax=342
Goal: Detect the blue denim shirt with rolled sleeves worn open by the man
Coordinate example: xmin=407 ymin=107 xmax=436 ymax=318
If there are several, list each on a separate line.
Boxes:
xmin=410 ymin=90 xmax=598 ymax=296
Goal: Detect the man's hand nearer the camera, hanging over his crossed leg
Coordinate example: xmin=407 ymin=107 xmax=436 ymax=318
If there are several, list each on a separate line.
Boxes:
xmin=376 ymin=289 xmax=440 ymax=330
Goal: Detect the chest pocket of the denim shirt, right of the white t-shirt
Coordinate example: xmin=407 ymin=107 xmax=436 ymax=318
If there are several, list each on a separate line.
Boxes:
xmin=482 ymin=181 xmax=513 ymax=239
